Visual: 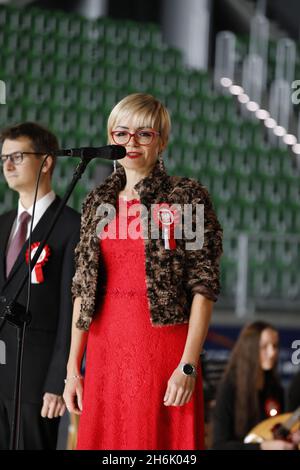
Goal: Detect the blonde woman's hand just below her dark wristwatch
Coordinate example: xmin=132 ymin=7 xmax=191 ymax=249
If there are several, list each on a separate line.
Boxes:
xmin=164 ymin=368 xmax=196 ymax=406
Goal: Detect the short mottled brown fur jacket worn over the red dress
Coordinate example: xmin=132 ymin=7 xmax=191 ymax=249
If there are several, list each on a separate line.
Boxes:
xmin=72 ymin=160 xmax=222 ymax=330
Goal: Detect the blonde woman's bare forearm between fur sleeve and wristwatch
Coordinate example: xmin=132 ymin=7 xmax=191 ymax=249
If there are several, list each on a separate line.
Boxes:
xmin=181 ymin=294 xmax=214 ymax=365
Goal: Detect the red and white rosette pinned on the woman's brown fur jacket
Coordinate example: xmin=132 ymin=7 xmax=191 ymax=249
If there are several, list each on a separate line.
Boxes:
xmin=153 ymin=203 xmax=179 ymax=250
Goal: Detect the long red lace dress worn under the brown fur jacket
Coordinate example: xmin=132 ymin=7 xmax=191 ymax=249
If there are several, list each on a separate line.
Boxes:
xmin=77 ymin=199 xmax=204 ymax=450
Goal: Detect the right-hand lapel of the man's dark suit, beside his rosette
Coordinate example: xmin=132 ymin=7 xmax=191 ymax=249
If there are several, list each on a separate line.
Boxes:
xmin=3 ymin=197 xmax=60 ymax=290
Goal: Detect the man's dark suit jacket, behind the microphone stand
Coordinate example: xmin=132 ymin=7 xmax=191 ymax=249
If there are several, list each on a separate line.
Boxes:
xmin=0 ymin=197 xmax=80 ymax=403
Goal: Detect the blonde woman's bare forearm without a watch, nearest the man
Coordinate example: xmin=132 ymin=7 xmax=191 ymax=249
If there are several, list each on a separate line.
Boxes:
xmin=67 ymin=297 xmax=88 ymax=375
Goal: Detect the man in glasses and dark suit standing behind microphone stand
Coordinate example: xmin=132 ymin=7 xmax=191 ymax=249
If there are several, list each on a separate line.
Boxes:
xmin=0 ymin=123 xmax=80 ymax=449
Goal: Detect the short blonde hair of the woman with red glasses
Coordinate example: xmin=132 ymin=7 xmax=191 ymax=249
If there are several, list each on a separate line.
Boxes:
xmin=107 ymin=93 xmax=171 ymax=145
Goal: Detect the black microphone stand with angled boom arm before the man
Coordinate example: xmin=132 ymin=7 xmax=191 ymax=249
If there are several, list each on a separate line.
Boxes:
xmin=0 ymin=156 xmax=92 ymax=450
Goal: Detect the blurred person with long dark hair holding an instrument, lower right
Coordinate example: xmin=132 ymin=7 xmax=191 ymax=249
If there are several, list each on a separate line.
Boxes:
xmin=213 ymin=321 xmax=298 ymax=450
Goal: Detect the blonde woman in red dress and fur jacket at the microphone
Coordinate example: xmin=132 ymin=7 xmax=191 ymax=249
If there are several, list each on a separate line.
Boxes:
xmin=64 ymin=94 xmax=222 ymax=450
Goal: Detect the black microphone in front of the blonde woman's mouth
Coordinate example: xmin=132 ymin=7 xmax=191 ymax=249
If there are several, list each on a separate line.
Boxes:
xmin=52 ymin=145 xmax=126 ymax=160
